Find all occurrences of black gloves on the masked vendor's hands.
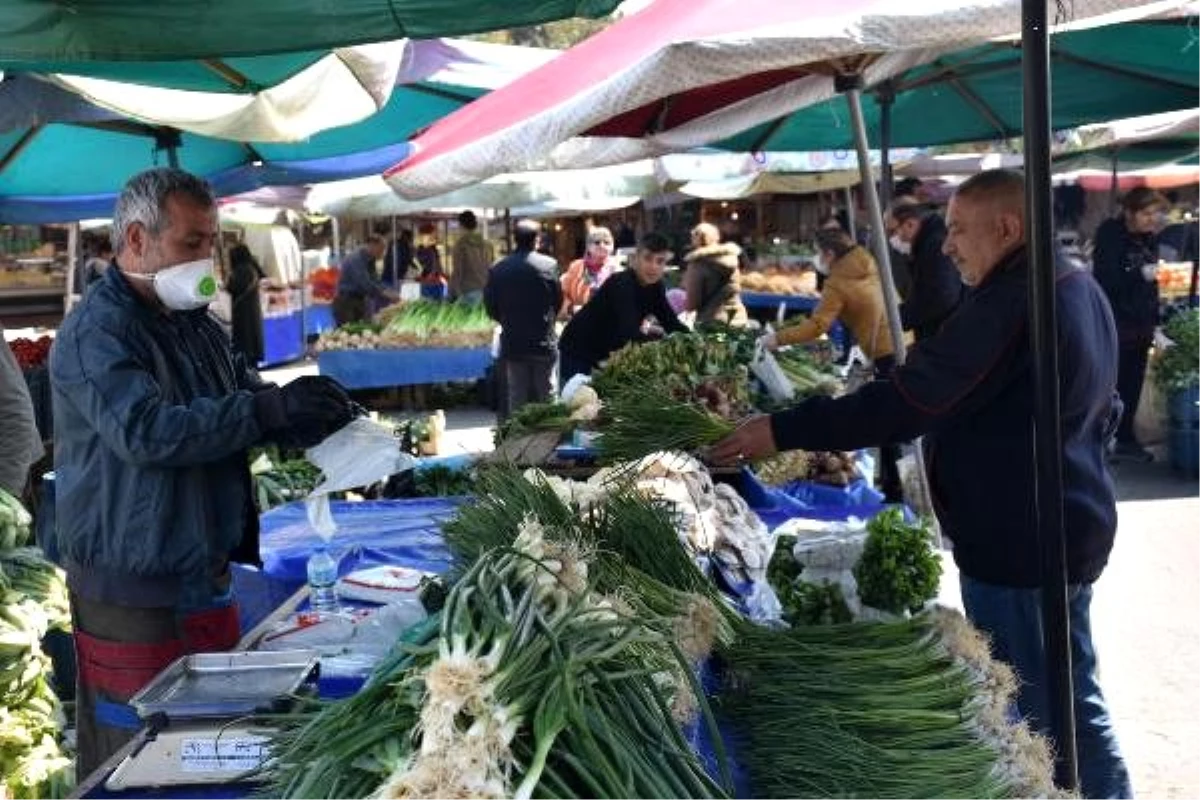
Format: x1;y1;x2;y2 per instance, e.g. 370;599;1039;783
254;375;359;447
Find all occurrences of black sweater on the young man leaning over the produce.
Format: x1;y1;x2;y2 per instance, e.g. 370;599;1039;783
558;270;688;369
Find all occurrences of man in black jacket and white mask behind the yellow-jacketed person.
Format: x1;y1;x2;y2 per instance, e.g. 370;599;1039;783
887;197;962;341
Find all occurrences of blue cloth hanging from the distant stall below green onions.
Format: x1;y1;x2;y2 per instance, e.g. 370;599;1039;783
317;348;492;389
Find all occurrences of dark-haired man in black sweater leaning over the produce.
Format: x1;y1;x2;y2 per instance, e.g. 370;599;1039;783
558;233;688;383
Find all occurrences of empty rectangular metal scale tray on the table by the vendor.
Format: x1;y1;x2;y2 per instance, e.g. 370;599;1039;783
130;650;318;720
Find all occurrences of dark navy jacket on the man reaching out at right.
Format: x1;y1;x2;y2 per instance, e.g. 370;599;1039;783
772;249;1121;588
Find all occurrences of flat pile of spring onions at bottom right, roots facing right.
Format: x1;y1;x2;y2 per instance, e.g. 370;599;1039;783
721;610;1055;800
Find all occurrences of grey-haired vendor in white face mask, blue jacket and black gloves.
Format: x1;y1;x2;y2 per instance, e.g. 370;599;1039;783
50;169;354;776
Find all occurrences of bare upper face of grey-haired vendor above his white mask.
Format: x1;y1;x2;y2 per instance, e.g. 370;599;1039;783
121;194;220;275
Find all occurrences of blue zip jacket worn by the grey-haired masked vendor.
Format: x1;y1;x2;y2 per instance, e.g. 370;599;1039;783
50;269;268;608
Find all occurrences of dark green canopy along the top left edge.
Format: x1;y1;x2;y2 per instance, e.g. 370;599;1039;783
0;0;618;62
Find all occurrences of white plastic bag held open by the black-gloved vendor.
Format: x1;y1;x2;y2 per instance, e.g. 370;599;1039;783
305;416;416;541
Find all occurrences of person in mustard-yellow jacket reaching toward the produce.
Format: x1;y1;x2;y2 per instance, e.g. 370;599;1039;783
766;228;895;374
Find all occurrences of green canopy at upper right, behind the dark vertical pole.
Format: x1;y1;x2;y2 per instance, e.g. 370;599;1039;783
715;19;1200;151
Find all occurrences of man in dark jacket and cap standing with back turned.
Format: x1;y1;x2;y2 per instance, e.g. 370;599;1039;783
484;219;563;422
